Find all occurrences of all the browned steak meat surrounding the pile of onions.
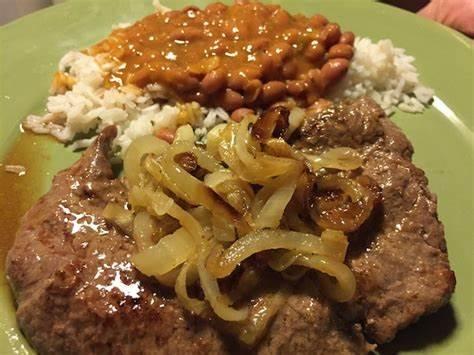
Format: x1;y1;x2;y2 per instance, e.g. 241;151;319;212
7;99;454;354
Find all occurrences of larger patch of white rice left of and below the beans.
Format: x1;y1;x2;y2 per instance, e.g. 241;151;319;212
24;52;229;152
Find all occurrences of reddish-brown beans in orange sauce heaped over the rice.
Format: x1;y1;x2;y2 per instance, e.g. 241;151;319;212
89;1;354;111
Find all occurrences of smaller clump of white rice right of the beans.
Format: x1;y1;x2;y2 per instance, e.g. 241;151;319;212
331;38;434;114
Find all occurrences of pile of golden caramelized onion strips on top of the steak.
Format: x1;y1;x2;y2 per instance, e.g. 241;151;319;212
121;105;362;326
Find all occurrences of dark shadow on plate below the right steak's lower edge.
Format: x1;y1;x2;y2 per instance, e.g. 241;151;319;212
378;303;457;355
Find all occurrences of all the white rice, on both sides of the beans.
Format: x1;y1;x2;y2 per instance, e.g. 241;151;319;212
24;34;433;153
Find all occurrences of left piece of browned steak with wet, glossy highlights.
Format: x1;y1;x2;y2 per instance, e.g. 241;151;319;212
7;127;368;354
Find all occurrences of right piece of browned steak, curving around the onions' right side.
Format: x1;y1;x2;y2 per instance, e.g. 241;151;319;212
297;98;456;344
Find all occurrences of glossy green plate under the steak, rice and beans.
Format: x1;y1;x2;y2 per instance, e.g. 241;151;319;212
0;0;474;354
